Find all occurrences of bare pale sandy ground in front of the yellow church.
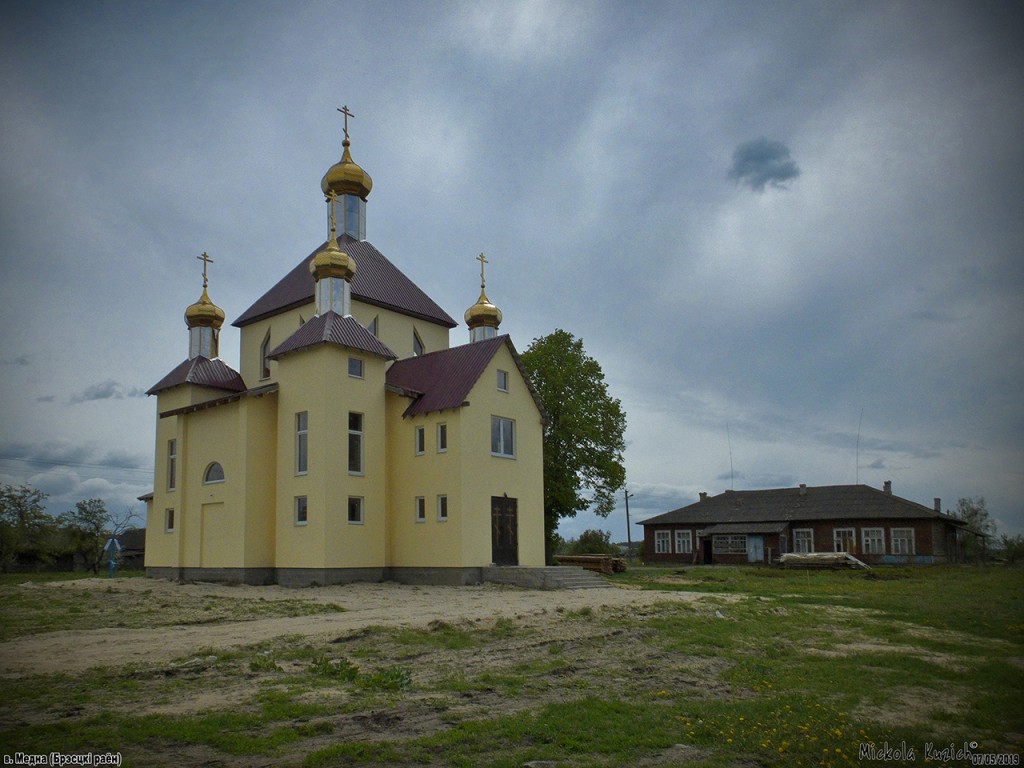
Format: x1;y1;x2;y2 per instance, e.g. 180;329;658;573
0;579;720;677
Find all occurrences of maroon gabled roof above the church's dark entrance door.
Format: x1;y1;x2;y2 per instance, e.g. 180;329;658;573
387;336;544;417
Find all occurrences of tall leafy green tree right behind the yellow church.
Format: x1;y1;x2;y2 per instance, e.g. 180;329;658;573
522;330;626;560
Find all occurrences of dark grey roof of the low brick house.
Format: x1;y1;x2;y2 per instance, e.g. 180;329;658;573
640;485;963;525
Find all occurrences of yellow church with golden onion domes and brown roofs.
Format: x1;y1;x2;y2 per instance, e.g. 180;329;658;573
144;110;544;586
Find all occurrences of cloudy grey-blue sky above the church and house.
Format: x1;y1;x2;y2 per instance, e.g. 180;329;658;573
0;0;1024;540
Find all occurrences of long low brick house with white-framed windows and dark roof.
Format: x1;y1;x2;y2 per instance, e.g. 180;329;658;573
640;480;970;564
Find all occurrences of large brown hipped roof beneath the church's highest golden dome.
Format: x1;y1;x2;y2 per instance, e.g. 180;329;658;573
231;234;458;328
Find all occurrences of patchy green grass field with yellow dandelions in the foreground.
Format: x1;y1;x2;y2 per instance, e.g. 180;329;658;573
0;566;1024;767
